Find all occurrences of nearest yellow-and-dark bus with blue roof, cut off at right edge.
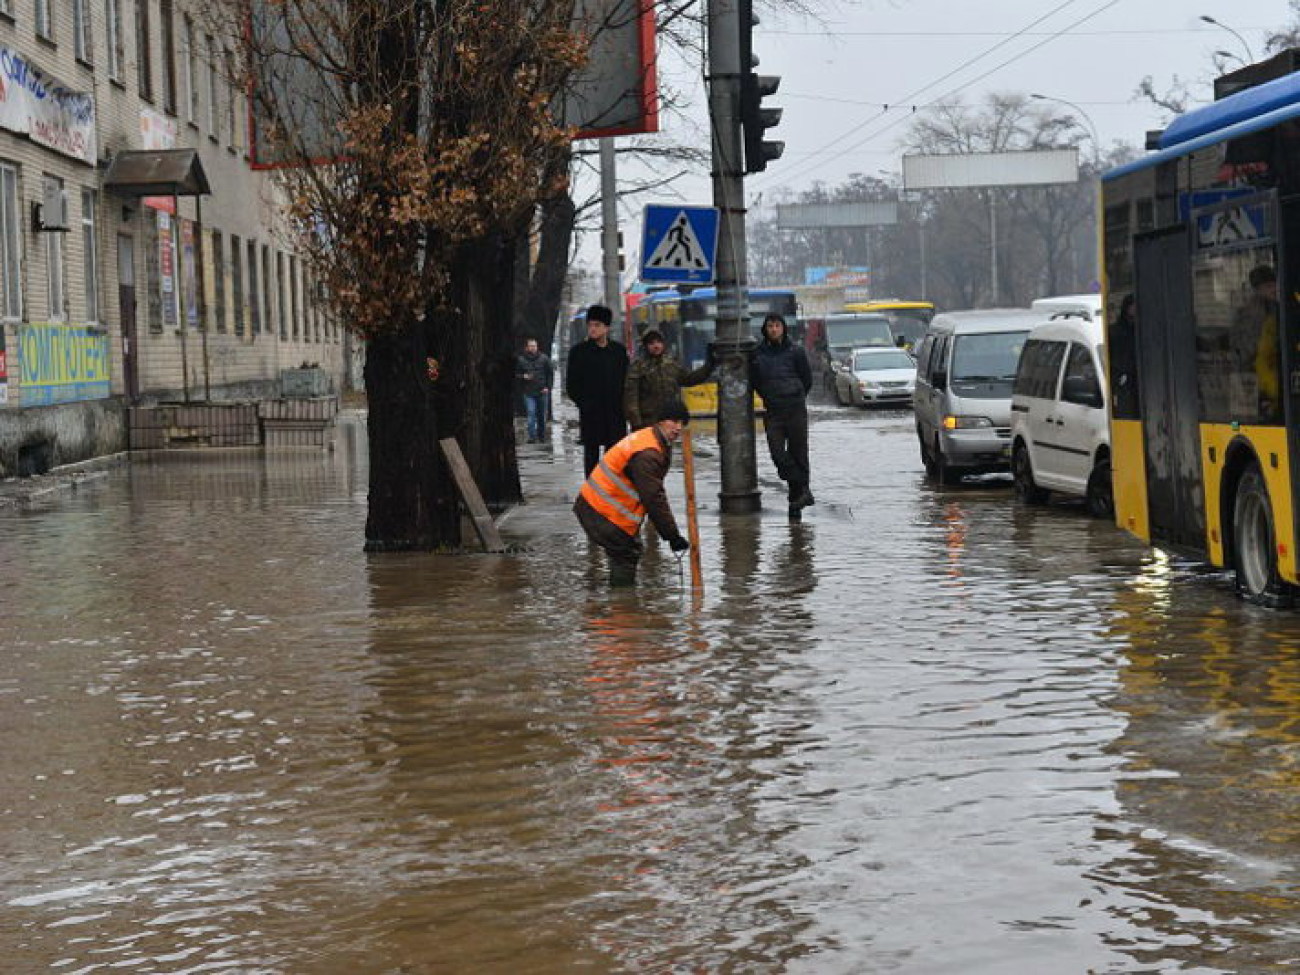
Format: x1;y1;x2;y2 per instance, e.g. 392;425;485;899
1101;62;1300;606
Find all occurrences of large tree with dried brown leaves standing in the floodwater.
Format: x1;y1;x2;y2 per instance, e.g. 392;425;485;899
212;0;588;550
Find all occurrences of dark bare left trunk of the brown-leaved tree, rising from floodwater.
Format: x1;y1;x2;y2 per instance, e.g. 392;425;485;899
365;325;462;551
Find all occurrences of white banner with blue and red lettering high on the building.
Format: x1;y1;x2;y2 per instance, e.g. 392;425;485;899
0;46;99;165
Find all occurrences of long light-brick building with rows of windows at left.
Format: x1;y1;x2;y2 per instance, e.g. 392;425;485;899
0;0;350;476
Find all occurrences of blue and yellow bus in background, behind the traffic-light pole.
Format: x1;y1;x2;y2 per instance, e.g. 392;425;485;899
628;287;803;416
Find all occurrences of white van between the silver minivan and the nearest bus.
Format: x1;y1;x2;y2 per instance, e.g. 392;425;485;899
1011;315;1114;517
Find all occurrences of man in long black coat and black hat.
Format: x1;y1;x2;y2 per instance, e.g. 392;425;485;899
564;304;628;475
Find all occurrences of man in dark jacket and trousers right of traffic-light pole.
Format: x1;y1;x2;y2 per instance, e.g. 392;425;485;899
749;313;813;519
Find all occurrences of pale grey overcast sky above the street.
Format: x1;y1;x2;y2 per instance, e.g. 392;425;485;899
584;0;1290;282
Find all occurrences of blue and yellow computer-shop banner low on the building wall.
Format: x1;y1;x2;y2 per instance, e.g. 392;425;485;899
18;321;109;407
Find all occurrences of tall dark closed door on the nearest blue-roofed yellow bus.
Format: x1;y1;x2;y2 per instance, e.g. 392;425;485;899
1134;225;1205;553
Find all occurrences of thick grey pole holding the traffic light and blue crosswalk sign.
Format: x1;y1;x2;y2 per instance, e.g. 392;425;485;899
709;0;762;514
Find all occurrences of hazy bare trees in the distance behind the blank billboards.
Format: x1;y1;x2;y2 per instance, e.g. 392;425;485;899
748;94;1136;308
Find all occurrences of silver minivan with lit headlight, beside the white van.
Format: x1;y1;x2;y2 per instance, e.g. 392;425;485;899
913;308;1043;484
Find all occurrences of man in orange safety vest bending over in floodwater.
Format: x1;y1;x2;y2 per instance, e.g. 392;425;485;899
573;402;690;586
